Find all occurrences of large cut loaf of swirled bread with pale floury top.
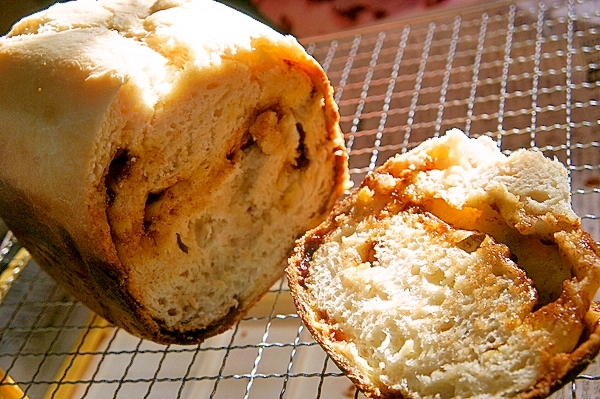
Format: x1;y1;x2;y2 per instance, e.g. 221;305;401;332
0;0;348;344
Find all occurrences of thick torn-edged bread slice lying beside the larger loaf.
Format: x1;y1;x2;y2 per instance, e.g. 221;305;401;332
287;130;600;399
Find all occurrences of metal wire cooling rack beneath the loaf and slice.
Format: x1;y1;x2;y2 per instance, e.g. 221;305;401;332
0;0;600;399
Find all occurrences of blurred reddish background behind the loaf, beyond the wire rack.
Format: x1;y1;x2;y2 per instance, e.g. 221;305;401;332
0;0;473;37
